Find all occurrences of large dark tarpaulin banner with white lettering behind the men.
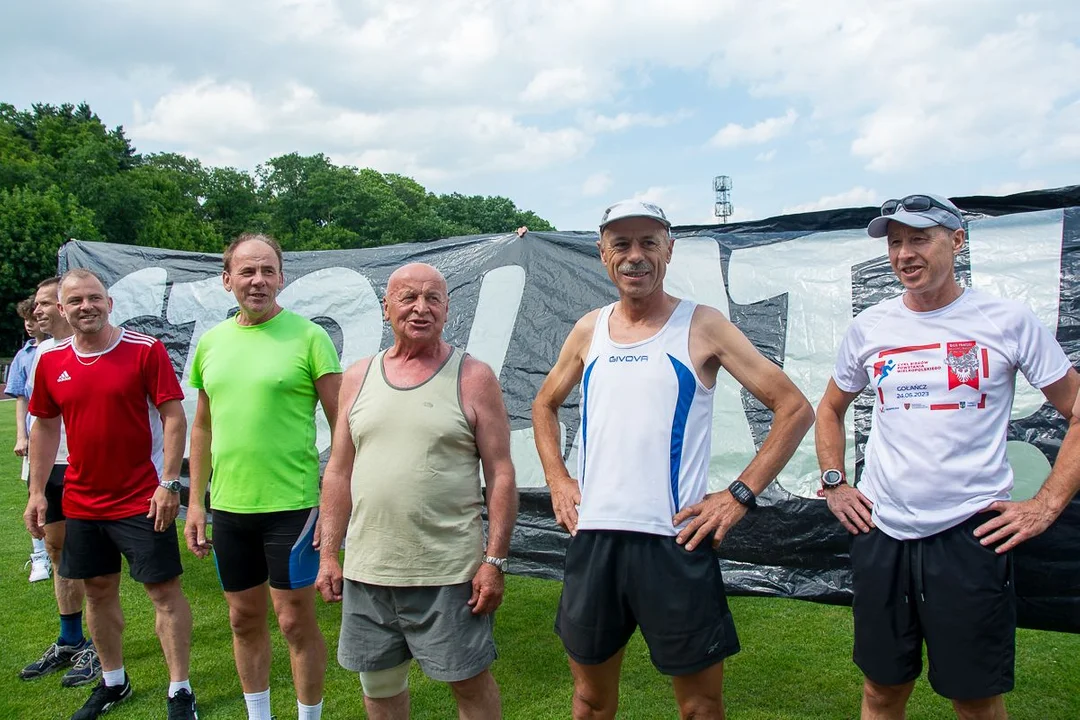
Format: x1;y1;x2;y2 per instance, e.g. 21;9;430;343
59;187;1080;633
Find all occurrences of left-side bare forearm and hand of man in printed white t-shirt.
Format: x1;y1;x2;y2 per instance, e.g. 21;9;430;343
814;378;874;534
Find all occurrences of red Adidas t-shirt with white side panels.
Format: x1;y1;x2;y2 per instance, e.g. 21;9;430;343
29;330;184;520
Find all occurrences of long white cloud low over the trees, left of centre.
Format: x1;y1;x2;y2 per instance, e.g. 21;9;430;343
131;79;592;181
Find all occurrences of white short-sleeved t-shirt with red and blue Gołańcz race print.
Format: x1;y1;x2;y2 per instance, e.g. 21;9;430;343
833;289;1070;540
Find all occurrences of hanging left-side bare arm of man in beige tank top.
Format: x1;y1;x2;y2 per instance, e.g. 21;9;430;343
315;357;372;602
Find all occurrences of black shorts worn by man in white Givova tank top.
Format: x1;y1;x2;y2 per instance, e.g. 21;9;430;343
555;530;739;675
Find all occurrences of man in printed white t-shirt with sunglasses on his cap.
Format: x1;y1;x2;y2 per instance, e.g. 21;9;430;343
815;194;1080;720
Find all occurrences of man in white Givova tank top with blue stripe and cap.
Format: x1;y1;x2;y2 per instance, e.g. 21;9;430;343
532;201;813;718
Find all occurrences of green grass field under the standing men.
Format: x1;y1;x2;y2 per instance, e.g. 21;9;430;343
0;402;1080;720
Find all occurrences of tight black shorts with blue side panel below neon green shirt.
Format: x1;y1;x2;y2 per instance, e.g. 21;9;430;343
212;507;319;593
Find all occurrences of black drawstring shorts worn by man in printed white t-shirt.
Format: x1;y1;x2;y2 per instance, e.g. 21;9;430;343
851;513;1016;699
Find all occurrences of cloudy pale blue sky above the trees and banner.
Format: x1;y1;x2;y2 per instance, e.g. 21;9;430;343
0;0;1080;230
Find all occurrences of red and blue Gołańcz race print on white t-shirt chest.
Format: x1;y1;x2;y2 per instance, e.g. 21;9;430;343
873;340;989;412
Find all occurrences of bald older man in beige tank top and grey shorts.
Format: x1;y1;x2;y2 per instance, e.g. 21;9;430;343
315;263;517;720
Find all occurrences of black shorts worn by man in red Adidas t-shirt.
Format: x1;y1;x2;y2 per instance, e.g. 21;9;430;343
60;514;184;583
